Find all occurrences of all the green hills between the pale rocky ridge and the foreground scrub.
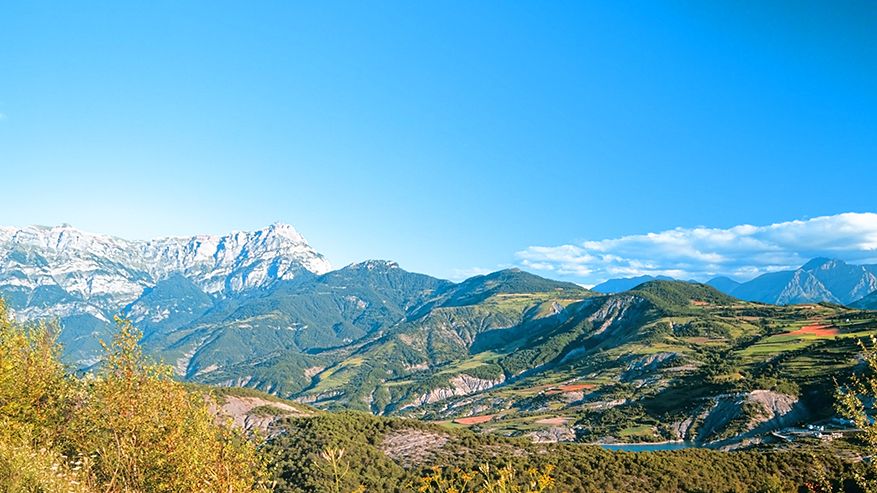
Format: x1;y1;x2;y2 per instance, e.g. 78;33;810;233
114;270;877;447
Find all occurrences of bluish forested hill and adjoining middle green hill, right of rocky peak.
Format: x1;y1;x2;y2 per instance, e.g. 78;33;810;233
164;262;594;413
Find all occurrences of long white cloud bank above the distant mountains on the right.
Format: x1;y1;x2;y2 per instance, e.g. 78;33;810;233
515;213;877;283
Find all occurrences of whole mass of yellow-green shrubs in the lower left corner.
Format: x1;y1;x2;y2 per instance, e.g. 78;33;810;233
0;300;266;493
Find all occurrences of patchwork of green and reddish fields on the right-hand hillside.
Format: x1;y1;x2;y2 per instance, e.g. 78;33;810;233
414;296;877;442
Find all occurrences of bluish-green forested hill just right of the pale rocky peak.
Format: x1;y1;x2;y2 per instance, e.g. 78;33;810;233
146;261;453;380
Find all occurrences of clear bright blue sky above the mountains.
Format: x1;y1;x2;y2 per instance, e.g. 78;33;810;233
0;1;877;284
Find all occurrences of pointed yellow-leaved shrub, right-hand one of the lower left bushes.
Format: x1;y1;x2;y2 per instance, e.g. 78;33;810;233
71;319;264;492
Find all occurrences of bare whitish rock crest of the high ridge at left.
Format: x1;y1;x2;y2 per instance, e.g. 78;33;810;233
0;223;331;318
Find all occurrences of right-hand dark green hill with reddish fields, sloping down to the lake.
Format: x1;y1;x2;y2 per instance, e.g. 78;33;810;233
407;281;877;442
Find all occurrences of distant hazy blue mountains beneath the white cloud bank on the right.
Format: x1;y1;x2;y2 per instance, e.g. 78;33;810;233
593;258;877;305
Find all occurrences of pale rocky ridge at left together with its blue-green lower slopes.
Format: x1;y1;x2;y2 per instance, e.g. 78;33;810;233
0;223;331;365
